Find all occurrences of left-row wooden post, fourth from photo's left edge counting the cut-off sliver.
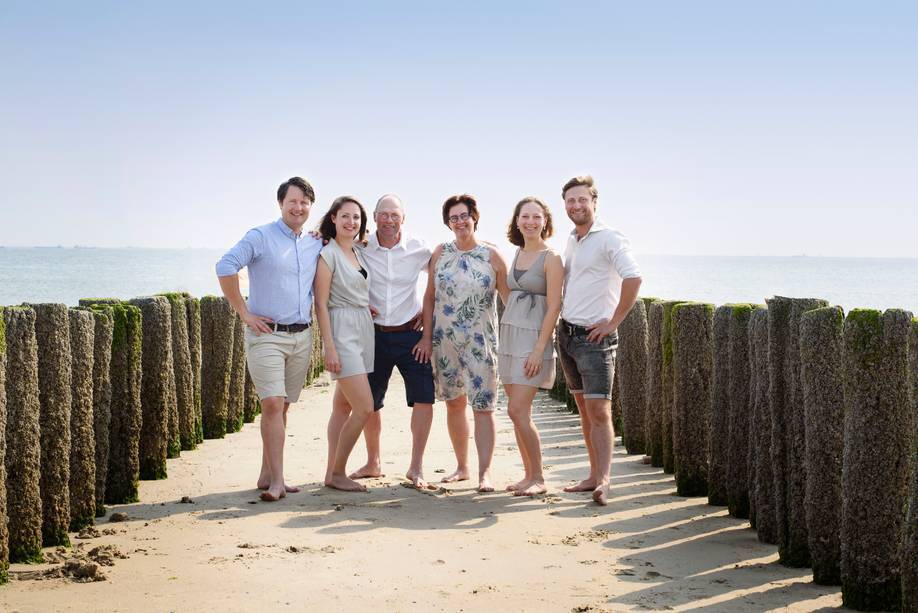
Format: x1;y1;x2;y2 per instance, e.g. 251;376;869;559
68;309;96;532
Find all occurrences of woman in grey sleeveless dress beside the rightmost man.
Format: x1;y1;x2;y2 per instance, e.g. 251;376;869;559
498;196;564;496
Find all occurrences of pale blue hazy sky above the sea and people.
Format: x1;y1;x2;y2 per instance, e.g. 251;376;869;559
0;0;918;257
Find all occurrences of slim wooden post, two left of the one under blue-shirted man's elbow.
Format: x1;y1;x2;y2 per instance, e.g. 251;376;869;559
163;293;198;451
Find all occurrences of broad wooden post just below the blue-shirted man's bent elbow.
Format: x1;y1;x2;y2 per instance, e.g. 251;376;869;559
201;296;236;439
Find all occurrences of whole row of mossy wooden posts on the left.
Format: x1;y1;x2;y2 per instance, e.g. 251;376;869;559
0;293;322;583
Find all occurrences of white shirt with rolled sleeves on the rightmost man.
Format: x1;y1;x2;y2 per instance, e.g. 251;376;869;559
561;219;641;326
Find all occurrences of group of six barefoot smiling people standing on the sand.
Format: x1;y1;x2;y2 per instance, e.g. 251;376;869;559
216;175;641;505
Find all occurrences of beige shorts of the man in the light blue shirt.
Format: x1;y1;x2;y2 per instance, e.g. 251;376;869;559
245;328;312;403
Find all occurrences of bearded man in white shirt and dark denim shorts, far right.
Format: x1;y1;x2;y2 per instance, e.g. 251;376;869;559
558;175;641;505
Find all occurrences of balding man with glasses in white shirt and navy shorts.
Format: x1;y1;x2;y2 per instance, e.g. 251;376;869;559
351;194;434;488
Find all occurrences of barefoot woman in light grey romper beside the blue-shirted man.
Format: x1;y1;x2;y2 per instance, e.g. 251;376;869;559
314;196;374;491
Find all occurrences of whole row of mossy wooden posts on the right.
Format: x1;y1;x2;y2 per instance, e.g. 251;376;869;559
552;297;918;611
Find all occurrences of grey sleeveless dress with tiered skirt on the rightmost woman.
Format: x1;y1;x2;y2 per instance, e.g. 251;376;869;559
497;249;555;389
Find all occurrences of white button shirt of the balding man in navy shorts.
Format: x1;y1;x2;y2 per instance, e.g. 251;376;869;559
363;230;431;326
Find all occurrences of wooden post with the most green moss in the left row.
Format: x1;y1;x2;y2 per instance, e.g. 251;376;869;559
105;304;143;504
